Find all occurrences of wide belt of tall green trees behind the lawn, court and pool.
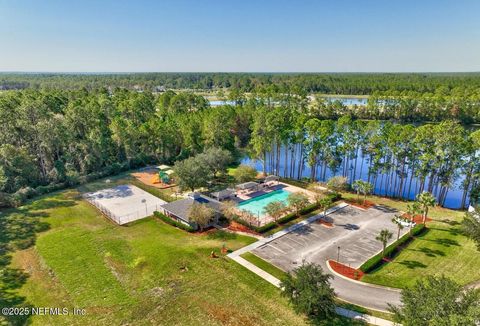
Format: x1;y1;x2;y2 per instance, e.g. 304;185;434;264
0;87;480;206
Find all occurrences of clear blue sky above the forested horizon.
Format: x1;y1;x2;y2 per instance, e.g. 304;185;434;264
0;0;480;72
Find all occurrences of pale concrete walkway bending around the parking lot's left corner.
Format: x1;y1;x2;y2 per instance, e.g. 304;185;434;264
228;203;397;326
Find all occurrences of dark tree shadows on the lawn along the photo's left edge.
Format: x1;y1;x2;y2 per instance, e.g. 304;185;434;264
0;198;56;325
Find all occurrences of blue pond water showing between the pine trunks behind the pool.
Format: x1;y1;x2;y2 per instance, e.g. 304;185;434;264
241;145;468;208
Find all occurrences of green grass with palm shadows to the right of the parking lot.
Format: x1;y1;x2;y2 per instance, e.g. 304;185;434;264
344;194;480;288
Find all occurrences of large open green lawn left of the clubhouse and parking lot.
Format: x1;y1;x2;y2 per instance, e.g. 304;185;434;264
0;186;312;325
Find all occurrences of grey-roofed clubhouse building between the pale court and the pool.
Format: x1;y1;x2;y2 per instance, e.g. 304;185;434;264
162;192;221;228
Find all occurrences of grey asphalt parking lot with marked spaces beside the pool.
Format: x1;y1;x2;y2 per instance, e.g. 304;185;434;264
252;206;408;271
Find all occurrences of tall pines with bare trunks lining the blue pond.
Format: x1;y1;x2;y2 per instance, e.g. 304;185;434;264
250;98;480;207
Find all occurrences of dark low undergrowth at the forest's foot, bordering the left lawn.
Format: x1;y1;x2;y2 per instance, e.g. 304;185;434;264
0;162;144;207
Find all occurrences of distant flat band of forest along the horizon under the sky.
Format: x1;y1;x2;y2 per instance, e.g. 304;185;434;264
0;73;480;95
